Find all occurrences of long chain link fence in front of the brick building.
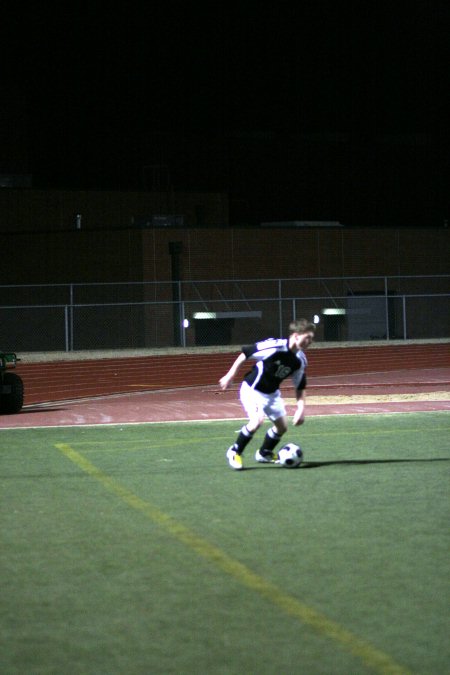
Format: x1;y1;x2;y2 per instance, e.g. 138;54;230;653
0;275;450;352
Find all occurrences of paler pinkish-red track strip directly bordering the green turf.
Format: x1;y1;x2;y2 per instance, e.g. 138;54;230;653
0;368;450;428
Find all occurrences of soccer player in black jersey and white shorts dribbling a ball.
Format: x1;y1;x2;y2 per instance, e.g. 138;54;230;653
219;319;316;470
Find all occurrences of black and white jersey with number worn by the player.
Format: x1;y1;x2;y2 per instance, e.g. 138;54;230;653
242;338;308;394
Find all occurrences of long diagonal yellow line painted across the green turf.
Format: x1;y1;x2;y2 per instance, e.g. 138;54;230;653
55;443;411;675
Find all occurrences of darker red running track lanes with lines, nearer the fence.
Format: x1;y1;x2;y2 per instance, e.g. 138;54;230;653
12;342;450;405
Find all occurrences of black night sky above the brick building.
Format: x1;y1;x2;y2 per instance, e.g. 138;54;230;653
0;0;449;225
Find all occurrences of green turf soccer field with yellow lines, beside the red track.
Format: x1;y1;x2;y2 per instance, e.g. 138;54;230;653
0;412;450;675
